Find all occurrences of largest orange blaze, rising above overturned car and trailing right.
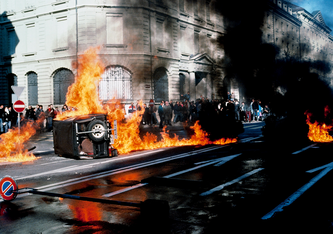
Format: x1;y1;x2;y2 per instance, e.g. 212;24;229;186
56;47;237;154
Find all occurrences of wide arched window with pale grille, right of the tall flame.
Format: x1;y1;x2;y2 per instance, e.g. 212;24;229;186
99;66;132;101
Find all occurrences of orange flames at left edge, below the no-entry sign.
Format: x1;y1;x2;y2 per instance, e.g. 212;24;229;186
0;118;44;162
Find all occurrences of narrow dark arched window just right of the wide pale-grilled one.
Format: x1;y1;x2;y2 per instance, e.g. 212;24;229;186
154;67;169;102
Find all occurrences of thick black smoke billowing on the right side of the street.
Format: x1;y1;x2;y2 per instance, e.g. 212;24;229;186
216;0;333;141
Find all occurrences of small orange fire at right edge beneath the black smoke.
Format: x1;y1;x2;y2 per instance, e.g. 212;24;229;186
305;107;333;142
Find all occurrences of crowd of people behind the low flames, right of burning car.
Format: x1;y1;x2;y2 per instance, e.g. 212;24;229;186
128;94;271;128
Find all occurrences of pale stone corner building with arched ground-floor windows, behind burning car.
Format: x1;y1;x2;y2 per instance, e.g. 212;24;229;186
0;0;223;105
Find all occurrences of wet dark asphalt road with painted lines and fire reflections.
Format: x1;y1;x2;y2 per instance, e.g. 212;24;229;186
0;122;333;233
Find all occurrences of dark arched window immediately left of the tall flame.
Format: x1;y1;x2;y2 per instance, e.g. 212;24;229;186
53;68;74;105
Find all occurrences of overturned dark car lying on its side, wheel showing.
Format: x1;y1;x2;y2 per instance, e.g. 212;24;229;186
53;114;118;158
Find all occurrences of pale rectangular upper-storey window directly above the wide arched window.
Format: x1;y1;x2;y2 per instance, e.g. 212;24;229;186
106;13;124;45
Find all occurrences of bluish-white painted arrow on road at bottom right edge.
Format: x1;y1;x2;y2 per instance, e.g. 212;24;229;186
261;162;333;219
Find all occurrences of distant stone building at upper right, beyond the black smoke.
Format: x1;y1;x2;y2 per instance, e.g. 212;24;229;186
262;0;333;77
